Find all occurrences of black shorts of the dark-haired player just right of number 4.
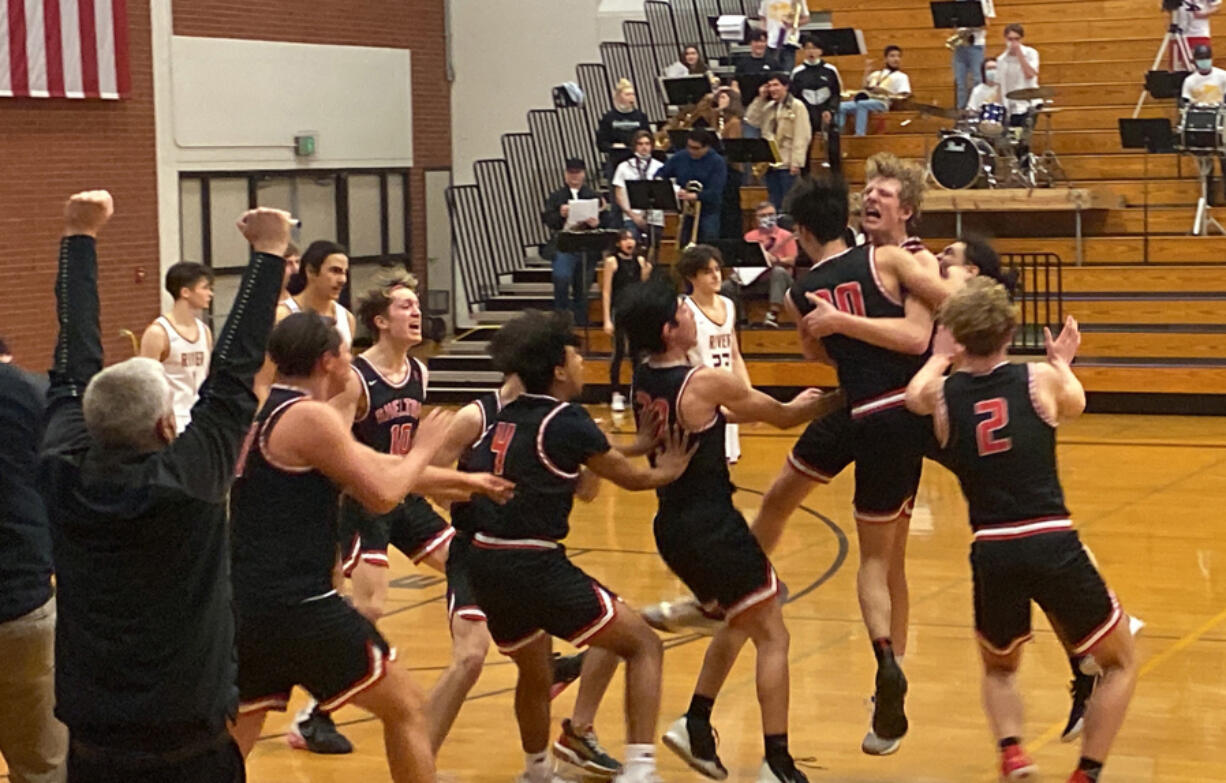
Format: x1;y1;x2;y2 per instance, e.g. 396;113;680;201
652;500;779;620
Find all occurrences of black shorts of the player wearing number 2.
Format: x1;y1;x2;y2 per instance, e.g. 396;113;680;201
971;520;1123;656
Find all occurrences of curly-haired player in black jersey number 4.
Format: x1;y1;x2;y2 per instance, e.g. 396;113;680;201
452;311;689;783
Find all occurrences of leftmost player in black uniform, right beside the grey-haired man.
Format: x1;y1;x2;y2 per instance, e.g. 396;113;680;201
230;312;450;783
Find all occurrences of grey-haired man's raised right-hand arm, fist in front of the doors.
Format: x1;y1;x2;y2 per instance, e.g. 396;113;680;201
162;208;291;502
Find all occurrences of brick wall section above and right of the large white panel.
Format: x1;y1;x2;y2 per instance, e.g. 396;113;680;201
174;0;451;289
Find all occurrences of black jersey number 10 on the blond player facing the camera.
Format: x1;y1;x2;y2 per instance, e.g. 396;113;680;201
353;357;425;456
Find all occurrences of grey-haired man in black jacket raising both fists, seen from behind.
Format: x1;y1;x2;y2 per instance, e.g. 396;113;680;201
40;191;289;783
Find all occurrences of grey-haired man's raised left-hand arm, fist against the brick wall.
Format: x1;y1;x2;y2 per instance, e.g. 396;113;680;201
43;190;115;460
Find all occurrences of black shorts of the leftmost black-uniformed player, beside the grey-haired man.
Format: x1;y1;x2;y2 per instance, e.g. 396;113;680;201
237;593;396;714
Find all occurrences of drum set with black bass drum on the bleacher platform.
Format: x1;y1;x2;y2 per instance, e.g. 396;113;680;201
907;87;1068;190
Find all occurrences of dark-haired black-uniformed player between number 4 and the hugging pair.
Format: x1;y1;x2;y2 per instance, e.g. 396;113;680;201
618;283;829;783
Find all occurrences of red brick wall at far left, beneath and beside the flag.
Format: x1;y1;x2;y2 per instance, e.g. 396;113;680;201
0;0;159;370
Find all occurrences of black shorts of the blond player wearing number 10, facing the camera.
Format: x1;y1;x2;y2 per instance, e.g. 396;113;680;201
340;495;455;576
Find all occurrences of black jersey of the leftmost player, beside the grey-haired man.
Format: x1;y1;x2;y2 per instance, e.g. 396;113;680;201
230;386;340;610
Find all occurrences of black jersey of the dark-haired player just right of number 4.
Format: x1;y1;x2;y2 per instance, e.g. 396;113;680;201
633;363;733;510
